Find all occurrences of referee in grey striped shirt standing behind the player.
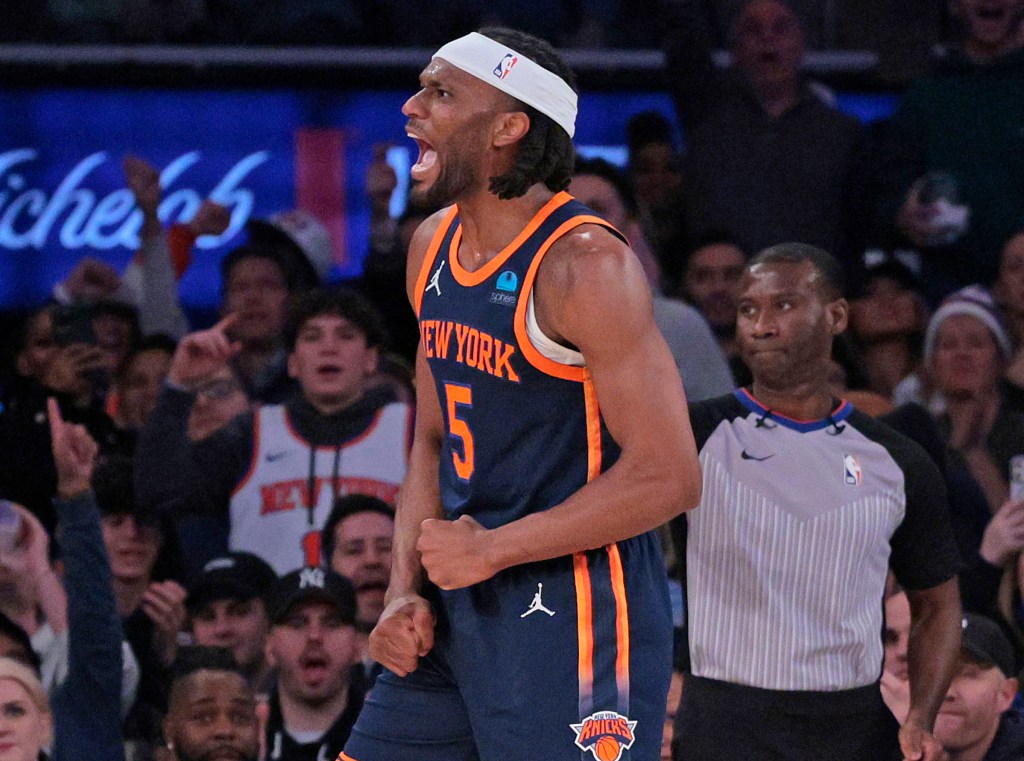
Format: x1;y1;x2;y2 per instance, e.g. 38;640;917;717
673;244;961;761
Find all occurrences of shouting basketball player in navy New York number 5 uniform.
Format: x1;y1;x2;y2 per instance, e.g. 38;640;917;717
341;30;700;761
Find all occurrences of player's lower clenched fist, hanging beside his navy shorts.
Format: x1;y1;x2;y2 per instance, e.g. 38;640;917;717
370;594;434;676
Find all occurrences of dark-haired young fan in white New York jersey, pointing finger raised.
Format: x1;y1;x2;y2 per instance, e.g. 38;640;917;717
137;289;411;573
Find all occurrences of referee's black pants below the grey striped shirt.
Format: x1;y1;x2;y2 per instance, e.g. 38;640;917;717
672;674;903;761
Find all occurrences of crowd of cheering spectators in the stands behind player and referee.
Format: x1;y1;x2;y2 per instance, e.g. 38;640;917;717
0;0;1024;761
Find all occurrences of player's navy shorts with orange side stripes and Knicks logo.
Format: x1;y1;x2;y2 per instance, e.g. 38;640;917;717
341;534;672;761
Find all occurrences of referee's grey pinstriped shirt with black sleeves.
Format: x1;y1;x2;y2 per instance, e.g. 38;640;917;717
674;389;959;691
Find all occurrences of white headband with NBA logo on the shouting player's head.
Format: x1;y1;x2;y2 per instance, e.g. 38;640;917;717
434;32;577;137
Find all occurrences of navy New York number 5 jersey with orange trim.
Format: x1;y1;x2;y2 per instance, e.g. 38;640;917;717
415;193;620;529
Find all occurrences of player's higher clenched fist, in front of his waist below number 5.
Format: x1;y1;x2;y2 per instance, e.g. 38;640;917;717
416;515;498;589
